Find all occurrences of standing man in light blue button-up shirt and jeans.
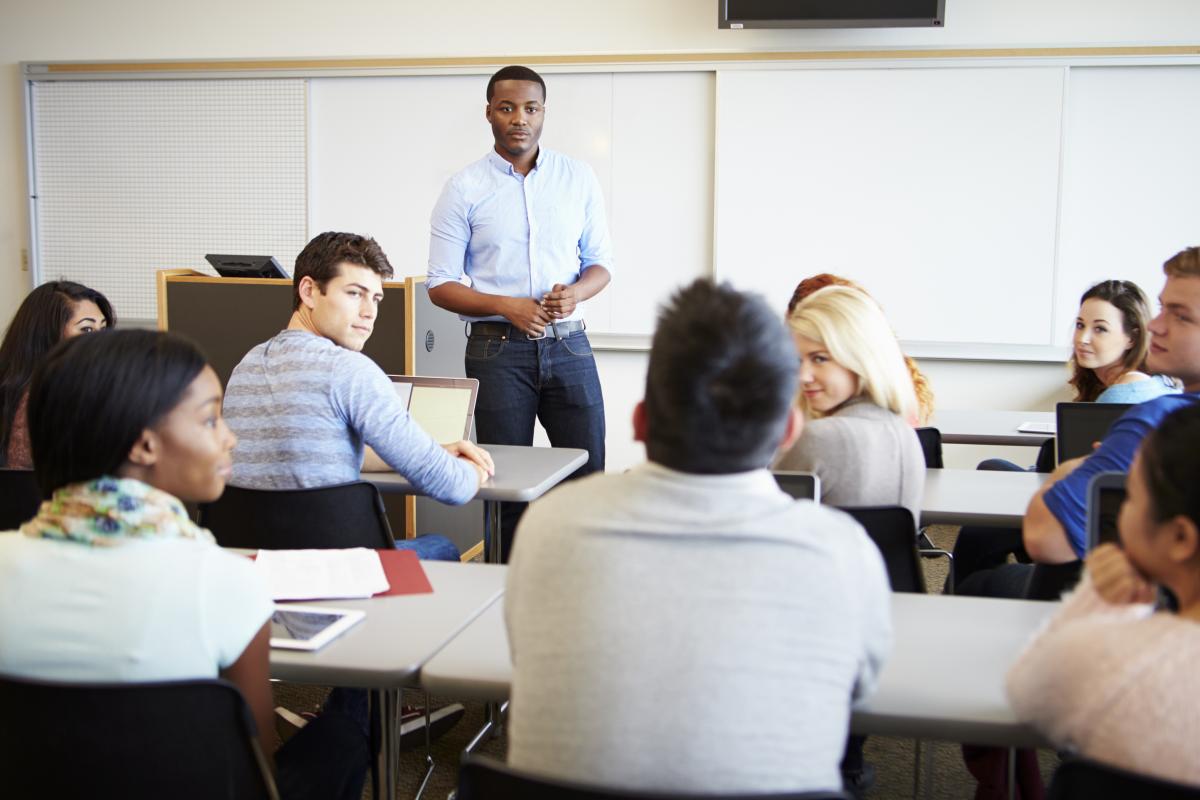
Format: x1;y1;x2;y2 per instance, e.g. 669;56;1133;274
426;66;612;561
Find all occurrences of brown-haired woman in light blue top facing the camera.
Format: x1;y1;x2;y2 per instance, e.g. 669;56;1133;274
1068;281;1180;403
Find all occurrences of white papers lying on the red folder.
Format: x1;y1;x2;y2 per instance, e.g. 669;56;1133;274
254;547;390;600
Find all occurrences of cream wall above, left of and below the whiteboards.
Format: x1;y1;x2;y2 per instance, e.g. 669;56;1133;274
0;0;1200;469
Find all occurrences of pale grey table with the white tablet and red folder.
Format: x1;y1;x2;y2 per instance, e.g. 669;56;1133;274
271;561;508;799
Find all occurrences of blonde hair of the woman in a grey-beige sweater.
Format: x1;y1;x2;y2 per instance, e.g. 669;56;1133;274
787;285;917;420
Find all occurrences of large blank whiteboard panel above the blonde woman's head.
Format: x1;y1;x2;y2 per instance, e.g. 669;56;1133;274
716;67;1064;347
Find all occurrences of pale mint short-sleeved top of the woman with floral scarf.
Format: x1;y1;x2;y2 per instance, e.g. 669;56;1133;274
0;533;272;682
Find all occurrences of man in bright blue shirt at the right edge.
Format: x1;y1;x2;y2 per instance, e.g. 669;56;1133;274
956;247;1200;597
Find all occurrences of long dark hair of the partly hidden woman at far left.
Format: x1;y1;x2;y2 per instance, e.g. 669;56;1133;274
0;281;116;463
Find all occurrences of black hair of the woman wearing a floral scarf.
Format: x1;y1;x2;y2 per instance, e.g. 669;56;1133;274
29;330;206;498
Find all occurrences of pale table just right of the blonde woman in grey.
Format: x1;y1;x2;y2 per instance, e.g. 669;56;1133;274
920;469;1050;528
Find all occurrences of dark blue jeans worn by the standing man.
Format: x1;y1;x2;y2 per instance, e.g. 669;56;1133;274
466;331;605;560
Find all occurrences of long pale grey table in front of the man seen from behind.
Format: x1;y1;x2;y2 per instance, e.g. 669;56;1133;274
420;594;1058;747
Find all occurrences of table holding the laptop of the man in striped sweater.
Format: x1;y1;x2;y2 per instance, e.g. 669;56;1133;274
359;445;588;564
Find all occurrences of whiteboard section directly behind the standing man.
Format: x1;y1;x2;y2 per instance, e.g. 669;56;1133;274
308;72;713;335
